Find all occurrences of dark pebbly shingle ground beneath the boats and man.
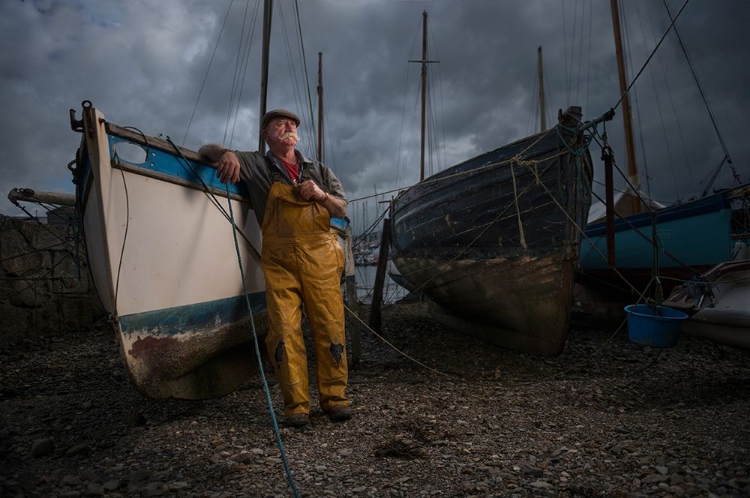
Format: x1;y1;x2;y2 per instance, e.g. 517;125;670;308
0;303;750;497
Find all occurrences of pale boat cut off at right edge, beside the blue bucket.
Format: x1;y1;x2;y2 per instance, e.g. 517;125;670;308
664;259;750;350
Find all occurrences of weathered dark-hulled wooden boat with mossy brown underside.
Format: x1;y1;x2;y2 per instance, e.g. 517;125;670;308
391;110;592;356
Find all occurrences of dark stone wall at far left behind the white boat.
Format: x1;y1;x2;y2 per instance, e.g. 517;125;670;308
0;215;105;347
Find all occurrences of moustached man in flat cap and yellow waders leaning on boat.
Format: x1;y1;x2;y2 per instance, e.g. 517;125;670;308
199;109;352;427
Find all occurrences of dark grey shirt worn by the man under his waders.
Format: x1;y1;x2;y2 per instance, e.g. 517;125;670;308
235;150;346;226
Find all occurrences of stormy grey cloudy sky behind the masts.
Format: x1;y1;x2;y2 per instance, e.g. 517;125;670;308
0;0;750;229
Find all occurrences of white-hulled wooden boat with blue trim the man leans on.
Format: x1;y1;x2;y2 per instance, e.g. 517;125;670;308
71;102;265;398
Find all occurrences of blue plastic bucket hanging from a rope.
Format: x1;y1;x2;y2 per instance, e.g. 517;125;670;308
625;304;688;348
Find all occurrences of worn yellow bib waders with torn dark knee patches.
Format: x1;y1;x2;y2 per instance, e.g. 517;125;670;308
262;182;349;417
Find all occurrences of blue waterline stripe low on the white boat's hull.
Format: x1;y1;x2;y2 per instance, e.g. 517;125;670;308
119;292;266;336
